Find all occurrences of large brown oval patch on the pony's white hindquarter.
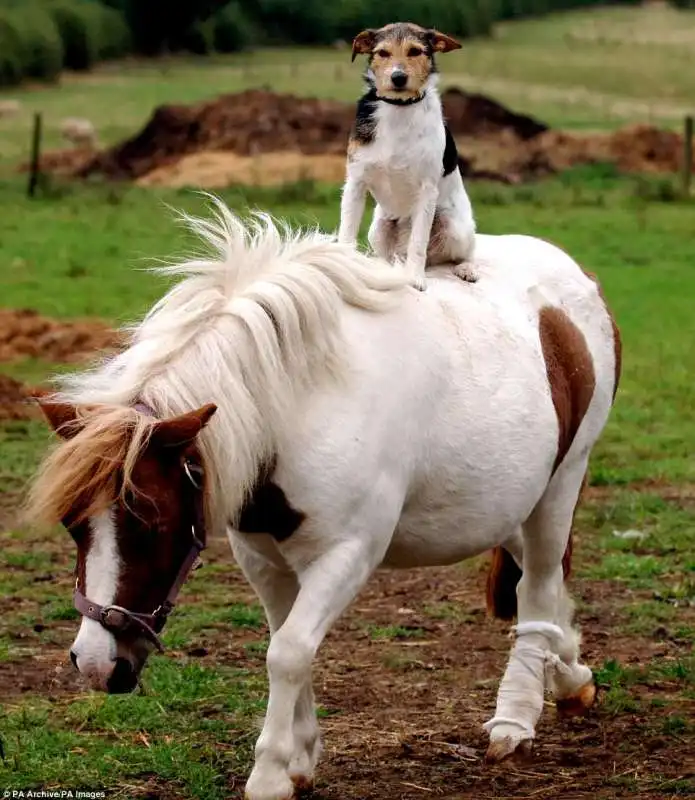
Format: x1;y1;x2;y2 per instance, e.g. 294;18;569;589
538;306;596;472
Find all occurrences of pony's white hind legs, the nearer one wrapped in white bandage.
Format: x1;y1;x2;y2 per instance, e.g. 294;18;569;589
485;461;593;761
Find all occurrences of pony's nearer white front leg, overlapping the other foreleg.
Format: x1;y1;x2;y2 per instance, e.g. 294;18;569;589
246;534;384;800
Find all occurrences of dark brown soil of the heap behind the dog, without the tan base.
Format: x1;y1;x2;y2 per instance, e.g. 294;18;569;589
69;89;547;180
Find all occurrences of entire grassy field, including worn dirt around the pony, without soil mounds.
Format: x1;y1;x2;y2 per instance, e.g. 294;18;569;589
0;9;695;800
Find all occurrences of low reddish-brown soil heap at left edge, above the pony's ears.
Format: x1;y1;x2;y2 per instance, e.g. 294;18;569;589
0;308;120;362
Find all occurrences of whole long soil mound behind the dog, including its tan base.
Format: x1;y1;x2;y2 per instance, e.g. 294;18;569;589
24;88;683;188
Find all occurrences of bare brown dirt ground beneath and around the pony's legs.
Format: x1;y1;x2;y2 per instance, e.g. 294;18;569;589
0;520;695;800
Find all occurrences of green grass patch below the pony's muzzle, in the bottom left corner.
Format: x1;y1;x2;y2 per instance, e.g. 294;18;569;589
0;658;263;800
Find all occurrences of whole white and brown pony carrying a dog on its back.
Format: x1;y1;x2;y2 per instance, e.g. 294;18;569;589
29;205;620;800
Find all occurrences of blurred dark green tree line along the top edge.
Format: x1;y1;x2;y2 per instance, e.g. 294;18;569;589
0;0;676;86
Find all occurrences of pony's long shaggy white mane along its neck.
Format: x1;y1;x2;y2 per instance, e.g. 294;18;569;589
60;199;406;530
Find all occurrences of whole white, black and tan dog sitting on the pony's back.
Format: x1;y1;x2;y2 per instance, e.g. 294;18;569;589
338;22;475;290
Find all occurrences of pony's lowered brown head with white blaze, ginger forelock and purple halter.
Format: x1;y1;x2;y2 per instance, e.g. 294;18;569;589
27;399;216;693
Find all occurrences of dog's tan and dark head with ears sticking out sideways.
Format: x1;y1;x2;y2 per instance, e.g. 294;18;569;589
352;22;461;99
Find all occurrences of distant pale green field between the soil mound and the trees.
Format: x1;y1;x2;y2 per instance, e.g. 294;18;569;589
0;7;695;169
